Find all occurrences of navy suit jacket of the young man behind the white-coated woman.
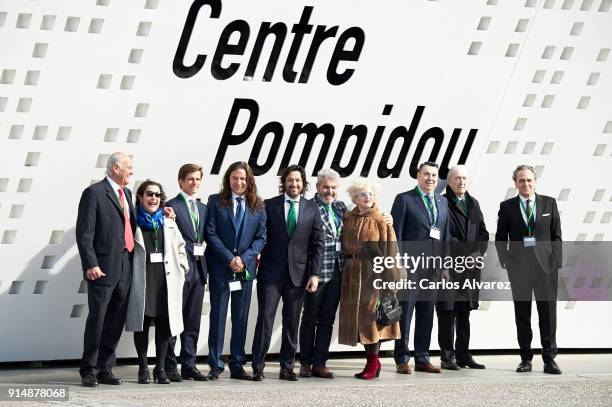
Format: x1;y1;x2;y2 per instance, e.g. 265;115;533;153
166;193;208;285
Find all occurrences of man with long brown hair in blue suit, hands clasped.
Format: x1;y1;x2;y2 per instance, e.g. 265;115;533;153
206;161;266;380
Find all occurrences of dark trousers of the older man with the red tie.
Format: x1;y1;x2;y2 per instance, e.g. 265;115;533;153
79;250;132;377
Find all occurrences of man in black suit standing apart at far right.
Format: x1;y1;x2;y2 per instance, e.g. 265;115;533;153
495;165;562;374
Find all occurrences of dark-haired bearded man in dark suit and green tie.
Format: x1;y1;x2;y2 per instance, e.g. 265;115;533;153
253;165;324;381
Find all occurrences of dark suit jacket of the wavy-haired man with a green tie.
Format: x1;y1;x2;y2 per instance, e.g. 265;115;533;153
257;194;324;287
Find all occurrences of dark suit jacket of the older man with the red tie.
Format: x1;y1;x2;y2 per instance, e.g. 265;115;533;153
75;179;136;286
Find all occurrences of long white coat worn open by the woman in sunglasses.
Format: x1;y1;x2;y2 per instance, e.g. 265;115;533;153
125;218;189;336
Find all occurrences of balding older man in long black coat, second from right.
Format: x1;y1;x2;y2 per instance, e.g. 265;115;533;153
436;165;489;370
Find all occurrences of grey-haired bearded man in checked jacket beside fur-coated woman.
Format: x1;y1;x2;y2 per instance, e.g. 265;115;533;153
299;169;346;379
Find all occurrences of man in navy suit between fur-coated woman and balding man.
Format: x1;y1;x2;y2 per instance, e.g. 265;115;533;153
391;162;450;374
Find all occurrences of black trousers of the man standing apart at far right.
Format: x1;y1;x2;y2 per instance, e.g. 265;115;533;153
508;256;558;363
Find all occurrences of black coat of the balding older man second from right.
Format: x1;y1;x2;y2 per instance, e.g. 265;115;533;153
437;186;489;310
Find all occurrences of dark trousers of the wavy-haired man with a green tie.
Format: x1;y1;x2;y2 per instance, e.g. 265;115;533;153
253;278;305;369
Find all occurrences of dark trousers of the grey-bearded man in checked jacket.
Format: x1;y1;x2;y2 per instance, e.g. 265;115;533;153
300;262;342;367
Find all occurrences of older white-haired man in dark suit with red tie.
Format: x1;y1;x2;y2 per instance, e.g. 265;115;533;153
76;153;136;387
